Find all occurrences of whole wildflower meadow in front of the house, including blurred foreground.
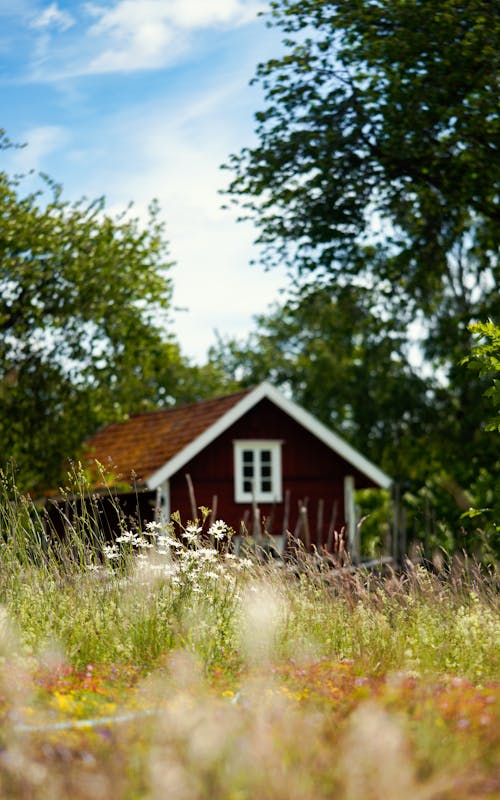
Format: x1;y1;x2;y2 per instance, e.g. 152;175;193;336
0;484;500;800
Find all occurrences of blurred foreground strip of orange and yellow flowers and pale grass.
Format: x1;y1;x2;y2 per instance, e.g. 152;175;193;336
0;654;498;800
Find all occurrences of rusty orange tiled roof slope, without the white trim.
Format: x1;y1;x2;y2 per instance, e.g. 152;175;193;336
84;389;251;483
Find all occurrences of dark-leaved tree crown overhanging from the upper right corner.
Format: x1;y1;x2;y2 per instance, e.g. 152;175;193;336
229;0;500;338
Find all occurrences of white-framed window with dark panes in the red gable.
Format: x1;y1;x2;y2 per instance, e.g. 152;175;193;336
234;439;283;503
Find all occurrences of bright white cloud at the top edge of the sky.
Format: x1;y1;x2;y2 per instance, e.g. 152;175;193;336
86;0;262;73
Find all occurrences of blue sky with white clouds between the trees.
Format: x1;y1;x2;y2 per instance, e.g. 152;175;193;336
0;0;286;362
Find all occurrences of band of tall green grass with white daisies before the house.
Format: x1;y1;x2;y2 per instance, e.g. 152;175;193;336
0;481;500;681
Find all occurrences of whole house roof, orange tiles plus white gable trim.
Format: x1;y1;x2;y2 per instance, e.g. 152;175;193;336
87;383;392;489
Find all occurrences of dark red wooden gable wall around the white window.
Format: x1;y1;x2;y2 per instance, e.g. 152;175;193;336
170;400;373;545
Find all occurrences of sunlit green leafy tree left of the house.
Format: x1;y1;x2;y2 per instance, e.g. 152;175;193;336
0;135;229;488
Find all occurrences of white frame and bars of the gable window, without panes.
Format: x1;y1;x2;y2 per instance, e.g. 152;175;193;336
233;439;283;503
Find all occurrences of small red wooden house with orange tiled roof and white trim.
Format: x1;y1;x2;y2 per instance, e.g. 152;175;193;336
82;383;391;551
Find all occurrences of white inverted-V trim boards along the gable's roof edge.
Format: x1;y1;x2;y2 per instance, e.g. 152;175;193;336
147;382;392;489
